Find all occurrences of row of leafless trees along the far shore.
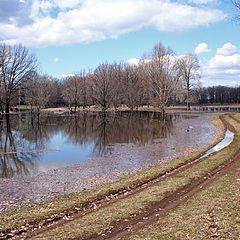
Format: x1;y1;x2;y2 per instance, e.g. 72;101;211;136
0;43;239;115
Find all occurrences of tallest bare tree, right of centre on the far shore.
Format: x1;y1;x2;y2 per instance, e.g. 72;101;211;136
142;43;179;116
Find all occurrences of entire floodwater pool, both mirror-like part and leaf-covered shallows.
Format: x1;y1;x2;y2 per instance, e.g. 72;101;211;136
0;112;216;211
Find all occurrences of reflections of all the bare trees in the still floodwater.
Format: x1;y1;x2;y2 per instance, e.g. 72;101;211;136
0;112;181;178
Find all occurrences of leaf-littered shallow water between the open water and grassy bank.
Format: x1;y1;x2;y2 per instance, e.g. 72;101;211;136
0;114;220;212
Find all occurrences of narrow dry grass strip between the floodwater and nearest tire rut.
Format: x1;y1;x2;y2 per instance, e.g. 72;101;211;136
0;117;223;235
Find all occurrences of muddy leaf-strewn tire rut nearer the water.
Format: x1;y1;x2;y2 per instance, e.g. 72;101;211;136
5;116;233;239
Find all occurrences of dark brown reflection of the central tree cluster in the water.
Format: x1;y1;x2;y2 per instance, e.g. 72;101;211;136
59;112;178;152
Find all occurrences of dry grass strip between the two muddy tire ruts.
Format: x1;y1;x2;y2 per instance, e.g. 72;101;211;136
28;117;240;239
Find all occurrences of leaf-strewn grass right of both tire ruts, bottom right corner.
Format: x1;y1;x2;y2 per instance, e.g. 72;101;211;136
130;114;240;240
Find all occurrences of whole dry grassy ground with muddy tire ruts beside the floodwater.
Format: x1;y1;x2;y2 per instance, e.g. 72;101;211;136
0;114;240;240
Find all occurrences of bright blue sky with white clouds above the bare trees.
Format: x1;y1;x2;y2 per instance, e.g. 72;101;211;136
0;0;240;86
